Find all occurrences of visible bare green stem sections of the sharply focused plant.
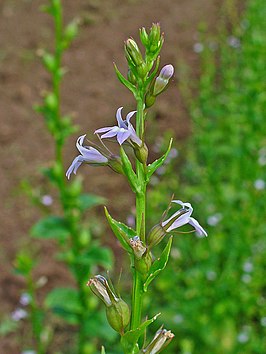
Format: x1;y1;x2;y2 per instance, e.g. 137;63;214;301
130;95;146;330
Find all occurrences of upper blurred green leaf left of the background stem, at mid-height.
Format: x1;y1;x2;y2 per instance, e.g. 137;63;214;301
31;215;69;240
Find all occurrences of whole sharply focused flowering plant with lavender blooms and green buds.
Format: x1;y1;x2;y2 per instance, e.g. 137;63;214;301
66;24;207;354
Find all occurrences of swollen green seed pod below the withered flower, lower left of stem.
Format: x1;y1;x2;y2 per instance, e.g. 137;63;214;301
106;299;130;335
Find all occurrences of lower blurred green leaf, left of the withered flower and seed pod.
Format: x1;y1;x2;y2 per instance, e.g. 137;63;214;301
44;288;83;324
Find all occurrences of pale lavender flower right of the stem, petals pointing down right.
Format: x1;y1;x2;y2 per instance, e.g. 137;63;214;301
162;200;208;236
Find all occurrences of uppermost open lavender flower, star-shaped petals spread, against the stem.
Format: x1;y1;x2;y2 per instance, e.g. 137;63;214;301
94;107;142;146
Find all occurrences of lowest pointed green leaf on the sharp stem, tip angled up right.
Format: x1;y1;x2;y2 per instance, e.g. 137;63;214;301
121;313;160;354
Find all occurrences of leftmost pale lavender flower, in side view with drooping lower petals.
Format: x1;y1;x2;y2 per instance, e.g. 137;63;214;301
66;135;108;179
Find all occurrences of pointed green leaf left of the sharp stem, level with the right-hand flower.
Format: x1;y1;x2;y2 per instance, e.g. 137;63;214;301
104;207;136;254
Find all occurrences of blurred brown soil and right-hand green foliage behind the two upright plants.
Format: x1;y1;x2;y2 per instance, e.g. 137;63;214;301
0;0;266;354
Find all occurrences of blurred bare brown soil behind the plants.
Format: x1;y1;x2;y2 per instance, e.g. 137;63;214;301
0;0;222;354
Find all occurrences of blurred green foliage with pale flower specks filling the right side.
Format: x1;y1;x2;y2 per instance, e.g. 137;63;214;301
147;0;266;354
